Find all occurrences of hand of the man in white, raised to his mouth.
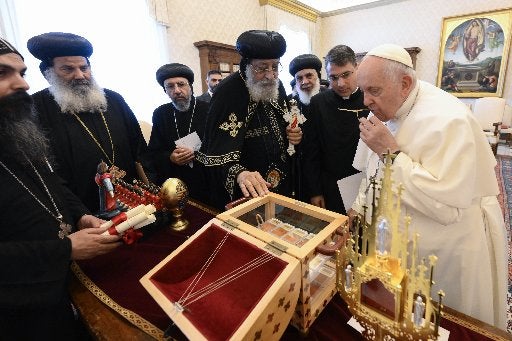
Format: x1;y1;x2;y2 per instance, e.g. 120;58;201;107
359;116;400;158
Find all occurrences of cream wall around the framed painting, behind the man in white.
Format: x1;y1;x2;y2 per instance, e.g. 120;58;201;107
317;0;512;104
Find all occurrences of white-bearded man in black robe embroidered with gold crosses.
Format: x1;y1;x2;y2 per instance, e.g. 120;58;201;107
197;30;302;209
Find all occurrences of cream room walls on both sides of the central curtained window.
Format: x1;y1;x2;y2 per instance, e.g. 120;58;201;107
161;0;512;105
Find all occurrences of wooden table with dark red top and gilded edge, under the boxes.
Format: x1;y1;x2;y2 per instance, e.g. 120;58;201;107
71;202;511;340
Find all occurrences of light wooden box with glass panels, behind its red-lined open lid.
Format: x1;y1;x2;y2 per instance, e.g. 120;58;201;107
217;193;348;332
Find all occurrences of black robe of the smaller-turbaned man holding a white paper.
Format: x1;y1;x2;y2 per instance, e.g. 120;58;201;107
148;98;208;202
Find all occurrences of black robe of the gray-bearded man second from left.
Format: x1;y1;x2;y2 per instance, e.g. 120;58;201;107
32;89;146;212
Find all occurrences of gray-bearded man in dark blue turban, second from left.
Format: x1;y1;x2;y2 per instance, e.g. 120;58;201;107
27;32;147;212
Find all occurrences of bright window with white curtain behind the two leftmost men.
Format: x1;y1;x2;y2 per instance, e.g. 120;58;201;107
0;0;169;122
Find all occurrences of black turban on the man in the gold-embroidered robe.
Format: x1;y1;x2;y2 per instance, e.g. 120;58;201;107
236;30;286;59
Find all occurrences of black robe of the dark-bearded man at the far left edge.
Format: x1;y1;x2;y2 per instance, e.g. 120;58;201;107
0;160;88;340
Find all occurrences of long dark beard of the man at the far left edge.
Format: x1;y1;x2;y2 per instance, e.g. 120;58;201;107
0;91;49;165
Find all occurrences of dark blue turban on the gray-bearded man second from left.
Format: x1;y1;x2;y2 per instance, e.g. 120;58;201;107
27;32;93;73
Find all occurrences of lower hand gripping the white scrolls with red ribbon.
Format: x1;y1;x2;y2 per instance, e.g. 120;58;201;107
68;228;121;260
